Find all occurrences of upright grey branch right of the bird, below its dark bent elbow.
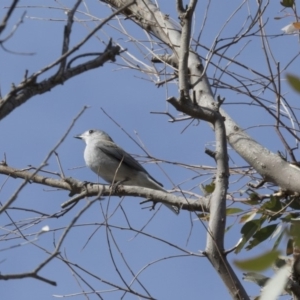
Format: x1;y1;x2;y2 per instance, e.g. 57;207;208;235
168;98;249;299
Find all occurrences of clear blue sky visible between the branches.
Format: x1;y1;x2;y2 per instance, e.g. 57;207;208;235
0;0;298;300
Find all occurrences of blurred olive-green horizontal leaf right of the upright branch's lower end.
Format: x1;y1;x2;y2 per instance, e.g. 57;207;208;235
233;250;280;270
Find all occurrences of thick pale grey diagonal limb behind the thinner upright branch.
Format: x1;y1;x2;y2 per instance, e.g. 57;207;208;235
103;0;300;194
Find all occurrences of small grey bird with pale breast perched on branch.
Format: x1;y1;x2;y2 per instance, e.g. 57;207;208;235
75;129;179;214
